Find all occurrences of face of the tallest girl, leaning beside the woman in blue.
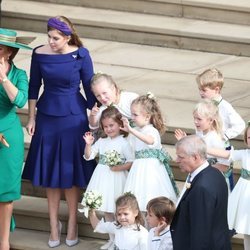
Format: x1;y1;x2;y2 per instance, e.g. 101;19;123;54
92;80;117;106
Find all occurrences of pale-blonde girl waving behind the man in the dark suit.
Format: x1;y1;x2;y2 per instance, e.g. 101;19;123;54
175;99;232;192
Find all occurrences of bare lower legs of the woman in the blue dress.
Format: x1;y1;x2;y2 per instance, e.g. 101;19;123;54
46;187;80;241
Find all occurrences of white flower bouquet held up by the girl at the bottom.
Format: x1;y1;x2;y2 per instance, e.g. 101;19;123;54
78;190;102;218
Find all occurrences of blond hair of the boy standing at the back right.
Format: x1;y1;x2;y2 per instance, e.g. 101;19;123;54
196;68;224;90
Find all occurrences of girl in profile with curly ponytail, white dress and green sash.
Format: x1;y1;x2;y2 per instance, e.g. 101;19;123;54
122;94;178;212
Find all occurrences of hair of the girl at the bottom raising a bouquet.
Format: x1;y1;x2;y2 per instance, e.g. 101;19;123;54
115;192;144;231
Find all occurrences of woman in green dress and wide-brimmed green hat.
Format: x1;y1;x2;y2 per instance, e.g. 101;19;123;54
0;28;33;250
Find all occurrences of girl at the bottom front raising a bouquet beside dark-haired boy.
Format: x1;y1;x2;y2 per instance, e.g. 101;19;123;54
89;193;148;250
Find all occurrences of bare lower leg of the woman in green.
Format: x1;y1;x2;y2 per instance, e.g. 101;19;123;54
0;202;13;250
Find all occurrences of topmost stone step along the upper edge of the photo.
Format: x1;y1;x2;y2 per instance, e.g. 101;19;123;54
21;0;250;25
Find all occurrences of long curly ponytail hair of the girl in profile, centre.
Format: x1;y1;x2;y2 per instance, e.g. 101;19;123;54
131;93;166;134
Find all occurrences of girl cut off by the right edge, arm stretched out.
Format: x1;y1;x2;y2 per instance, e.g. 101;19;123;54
208;121;250;250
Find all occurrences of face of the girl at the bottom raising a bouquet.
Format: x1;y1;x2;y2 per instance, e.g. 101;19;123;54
116;207;138;226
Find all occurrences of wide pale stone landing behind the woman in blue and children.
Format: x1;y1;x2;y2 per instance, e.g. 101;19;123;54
9;31;250;129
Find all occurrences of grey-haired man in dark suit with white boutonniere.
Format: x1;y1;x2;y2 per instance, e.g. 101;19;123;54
171;135;231;250
